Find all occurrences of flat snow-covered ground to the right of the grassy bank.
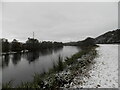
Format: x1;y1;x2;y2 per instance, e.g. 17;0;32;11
73;45;118;88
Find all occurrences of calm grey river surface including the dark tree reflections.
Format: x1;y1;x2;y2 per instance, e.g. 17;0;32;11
2;46;80;85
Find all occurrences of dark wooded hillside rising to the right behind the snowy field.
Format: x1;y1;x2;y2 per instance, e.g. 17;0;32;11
64;29;120;46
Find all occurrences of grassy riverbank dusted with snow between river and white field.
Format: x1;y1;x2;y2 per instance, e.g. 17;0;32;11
3;47;97;89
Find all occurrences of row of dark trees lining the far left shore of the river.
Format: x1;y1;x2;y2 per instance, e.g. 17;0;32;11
1;38;63;52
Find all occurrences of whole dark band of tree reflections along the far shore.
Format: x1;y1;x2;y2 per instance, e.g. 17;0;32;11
2;47;63;68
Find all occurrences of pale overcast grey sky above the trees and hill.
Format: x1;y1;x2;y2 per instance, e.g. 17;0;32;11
2;2;118;42
